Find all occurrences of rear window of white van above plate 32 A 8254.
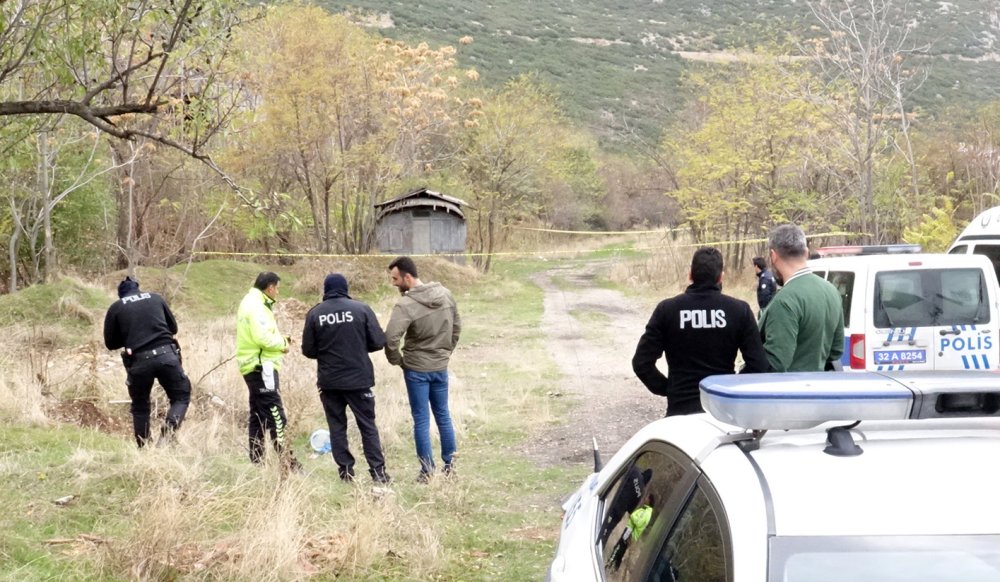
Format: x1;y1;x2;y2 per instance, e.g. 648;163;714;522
873;269;990;328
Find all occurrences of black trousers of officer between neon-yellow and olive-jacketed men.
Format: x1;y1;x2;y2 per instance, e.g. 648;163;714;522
319;389;386;479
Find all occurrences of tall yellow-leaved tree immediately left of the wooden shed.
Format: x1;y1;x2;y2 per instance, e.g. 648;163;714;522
227;5;475;252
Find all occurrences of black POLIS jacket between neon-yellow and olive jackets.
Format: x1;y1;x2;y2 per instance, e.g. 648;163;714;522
302;295;385;390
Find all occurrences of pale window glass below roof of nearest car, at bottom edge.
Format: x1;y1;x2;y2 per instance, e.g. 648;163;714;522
768;535;1000;582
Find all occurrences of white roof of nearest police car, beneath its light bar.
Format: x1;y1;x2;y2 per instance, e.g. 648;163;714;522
748;418;1000;536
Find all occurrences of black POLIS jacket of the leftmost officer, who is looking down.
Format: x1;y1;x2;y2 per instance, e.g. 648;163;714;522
104;291;177;354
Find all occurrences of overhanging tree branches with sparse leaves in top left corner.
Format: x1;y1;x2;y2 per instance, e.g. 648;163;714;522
0;0;255;224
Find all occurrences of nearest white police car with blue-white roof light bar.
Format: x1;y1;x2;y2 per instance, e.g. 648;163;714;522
548;371;1000;582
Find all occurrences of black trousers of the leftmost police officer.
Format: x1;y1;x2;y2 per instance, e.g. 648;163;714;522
126;352;191;447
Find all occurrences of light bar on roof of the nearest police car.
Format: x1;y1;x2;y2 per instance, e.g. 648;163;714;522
701;371;1000;430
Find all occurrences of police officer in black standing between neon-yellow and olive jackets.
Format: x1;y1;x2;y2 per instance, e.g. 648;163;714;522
302;273;389;483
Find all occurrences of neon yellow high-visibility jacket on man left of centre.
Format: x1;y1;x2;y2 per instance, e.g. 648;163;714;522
236;287;287;376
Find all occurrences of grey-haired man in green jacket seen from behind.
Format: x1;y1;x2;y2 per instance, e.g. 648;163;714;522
760;224;844;372
